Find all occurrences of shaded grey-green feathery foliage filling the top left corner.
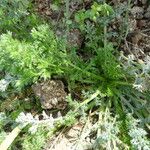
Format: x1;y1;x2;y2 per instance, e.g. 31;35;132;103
0;0;41;39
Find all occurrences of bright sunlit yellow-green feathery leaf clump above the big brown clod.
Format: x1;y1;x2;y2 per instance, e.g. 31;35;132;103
0;25;67;87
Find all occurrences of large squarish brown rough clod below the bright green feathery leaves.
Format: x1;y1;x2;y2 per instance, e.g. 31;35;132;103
32;80;67;109
